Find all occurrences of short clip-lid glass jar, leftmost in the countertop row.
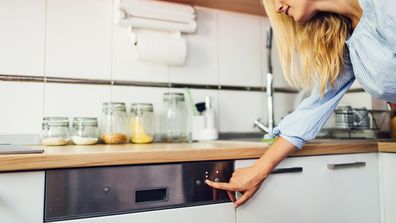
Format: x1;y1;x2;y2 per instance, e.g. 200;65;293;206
41;117;70;146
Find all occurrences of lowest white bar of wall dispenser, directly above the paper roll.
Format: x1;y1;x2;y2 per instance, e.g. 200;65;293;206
122;16;197;33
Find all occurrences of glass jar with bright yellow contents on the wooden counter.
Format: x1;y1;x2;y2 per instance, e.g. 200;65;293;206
129;103;154;143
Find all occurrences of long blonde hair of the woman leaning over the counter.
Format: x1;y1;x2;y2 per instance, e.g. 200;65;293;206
262;0;350;95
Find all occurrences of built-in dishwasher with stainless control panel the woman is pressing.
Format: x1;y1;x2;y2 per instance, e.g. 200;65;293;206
44;161;235;223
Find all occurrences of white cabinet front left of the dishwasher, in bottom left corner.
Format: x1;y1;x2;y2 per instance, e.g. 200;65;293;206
0;172;44;223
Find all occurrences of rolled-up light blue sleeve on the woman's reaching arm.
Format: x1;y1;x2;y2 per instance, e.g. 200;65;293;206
273;66;355;149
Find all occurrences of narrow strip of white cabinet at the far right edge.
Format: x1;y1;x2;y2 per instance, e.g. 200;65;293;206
380;153;396;223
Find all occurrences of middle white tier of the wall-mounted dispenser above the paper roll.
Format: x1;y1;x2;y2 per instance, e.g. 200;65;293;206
120;3;195;23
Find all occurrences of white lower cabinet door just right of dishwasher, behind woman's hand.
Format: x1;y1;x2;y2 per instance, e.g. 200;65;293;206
236;158;313;223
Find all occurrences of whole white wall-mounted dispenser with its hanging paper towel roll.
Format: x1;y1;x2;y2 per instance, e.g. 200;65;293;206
120;0;197;66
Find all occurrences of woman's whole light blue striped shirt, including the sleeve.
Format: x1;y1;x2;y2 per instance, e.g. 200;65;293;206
273;0;396;149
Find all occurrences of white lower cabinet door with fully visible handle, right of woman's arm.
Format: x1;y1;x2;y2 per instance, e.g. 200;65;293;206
307;153;380;223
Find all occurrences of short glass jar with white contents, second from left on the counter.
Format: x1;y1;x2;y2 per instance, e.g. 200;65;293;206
71;117;99;145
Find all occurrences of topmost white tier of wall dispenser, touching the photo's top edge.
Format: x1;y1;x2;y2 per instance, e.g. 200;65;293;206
121;0;195;14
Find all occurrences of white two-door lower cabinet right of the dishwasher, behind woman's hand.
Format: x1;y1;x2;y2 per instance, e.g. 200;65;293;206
236;153;380;223
